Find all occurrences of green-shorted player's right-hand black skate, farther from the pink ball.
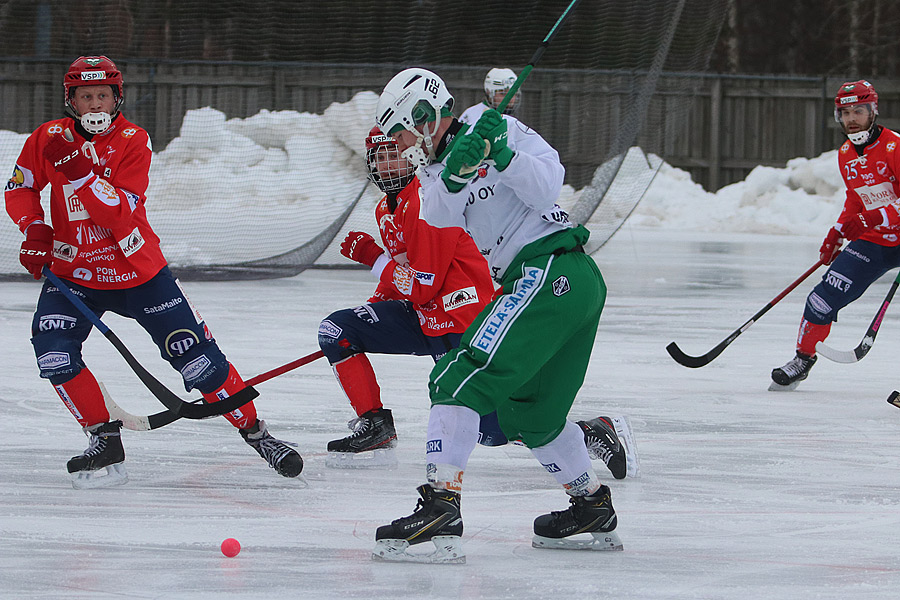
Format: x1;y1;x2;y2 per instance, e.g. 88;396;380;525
531;485;623;550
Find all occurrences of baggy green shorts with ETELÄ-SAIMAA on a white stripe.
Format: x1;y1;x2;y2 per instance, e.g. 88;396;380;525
429;232;606;448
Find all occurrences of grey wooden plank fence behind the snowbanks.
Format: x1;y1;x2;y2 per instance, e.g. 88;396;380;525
0;59;900;190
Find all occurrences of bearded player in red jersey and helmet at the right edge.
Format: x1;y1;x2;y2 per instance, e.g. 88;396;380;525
769;81;900;391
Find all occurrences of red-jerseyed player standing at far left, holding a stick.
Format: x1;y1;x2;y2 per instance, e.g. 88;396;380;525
5;56;303;488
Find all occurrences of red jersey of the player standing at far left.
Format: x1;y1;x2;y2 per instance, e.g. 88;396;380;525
6;114;166;289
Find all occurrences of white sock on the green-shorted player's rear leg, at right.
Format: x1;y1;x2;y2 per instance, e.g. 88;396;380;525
531;420;600;496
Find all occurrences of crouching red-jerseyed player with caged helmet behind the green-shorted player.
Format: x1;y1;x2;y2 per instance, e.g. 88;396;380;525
319;127;637;479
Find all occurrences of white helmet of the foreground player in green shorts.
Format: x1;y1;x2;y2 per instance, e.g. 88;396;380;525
375;68;453;167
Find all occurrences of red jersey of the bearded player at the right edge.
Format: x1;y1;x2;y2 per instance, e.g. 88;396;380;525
838;127;900;246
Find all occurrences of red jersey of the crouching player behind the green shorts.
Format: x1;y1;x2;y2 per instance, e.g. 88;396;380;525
370;178;494;336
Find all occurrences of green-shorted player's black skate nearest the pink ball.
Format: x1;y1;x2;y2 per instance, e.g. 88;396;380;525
372;483;466;563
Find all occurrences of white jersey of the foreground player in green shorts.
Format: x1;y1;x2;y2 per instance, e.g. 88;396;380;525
418;115;571;281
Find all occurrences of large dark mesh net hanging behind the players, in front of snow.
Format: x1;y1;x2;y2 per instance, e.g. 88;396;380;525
0;0;726;278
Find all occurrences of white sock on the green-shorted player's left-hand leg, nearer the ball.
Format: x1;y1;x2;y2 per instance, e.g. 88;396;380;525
425;404;481;492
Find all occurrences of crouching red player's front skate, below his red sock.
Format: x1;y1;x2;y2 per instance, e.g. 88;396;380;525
325;408;397;468
